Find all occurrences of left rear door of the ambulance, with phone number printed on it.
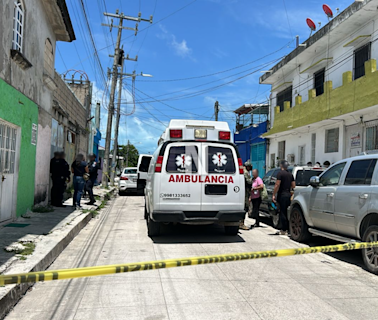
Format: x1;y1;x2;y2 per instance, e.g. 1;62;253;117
159;142;202;211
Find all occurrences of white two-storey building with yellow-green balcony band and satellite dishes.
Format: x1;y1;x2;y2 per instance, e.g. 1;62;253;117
260;0;378;167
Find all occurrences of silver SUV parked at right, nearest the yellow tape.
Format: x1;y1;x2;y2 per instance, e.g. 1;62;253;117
289;154;378;274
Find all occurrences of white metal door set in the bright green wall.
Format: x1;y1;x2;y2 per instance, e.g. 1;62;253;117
0;120;17;222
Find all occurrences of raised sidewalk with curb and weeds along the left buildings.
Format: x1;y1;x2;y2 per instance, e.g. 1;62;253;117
0;187;115;319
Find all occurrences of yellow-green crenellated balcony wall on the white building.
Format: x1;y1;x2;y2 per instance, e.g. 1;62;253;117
264;59;378;136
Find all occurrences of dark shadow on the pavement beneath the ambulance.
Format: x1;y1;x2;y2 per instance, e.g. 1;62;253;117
151;224;245;244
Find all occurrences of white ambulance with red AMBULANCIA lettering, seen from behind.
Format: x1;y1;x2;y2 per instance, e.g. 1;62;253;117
145;120;245;236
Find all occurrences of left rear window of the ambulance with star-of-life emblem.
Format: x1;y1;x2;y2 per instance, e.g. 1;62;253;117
167;146;198;173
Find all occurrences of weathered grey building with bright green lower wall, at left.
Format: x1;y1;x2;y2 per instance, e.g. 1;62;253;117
0;0;75;223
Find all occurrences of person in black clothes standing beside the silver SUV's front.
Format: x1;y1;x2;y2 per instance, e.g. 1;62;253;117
272;160;295;234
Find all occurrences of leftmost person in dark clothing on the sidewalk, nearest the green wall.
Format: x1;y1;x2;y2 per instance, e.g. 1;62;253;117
50;151;66;207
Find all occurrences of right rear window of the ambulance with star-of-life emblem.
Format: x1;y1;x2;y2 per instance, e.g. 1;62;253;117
207;147;236;173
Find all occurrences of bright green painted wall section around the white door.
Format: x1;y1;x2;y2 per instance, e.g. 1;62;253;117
0;79;38;216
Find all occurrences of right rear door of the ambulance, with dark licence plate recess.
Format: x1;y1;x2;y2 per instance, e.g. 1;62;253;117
201;143;244;211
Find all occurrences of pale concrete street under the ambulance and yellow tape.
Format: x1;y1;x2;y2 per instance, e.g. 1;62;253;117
6;196;378;320
